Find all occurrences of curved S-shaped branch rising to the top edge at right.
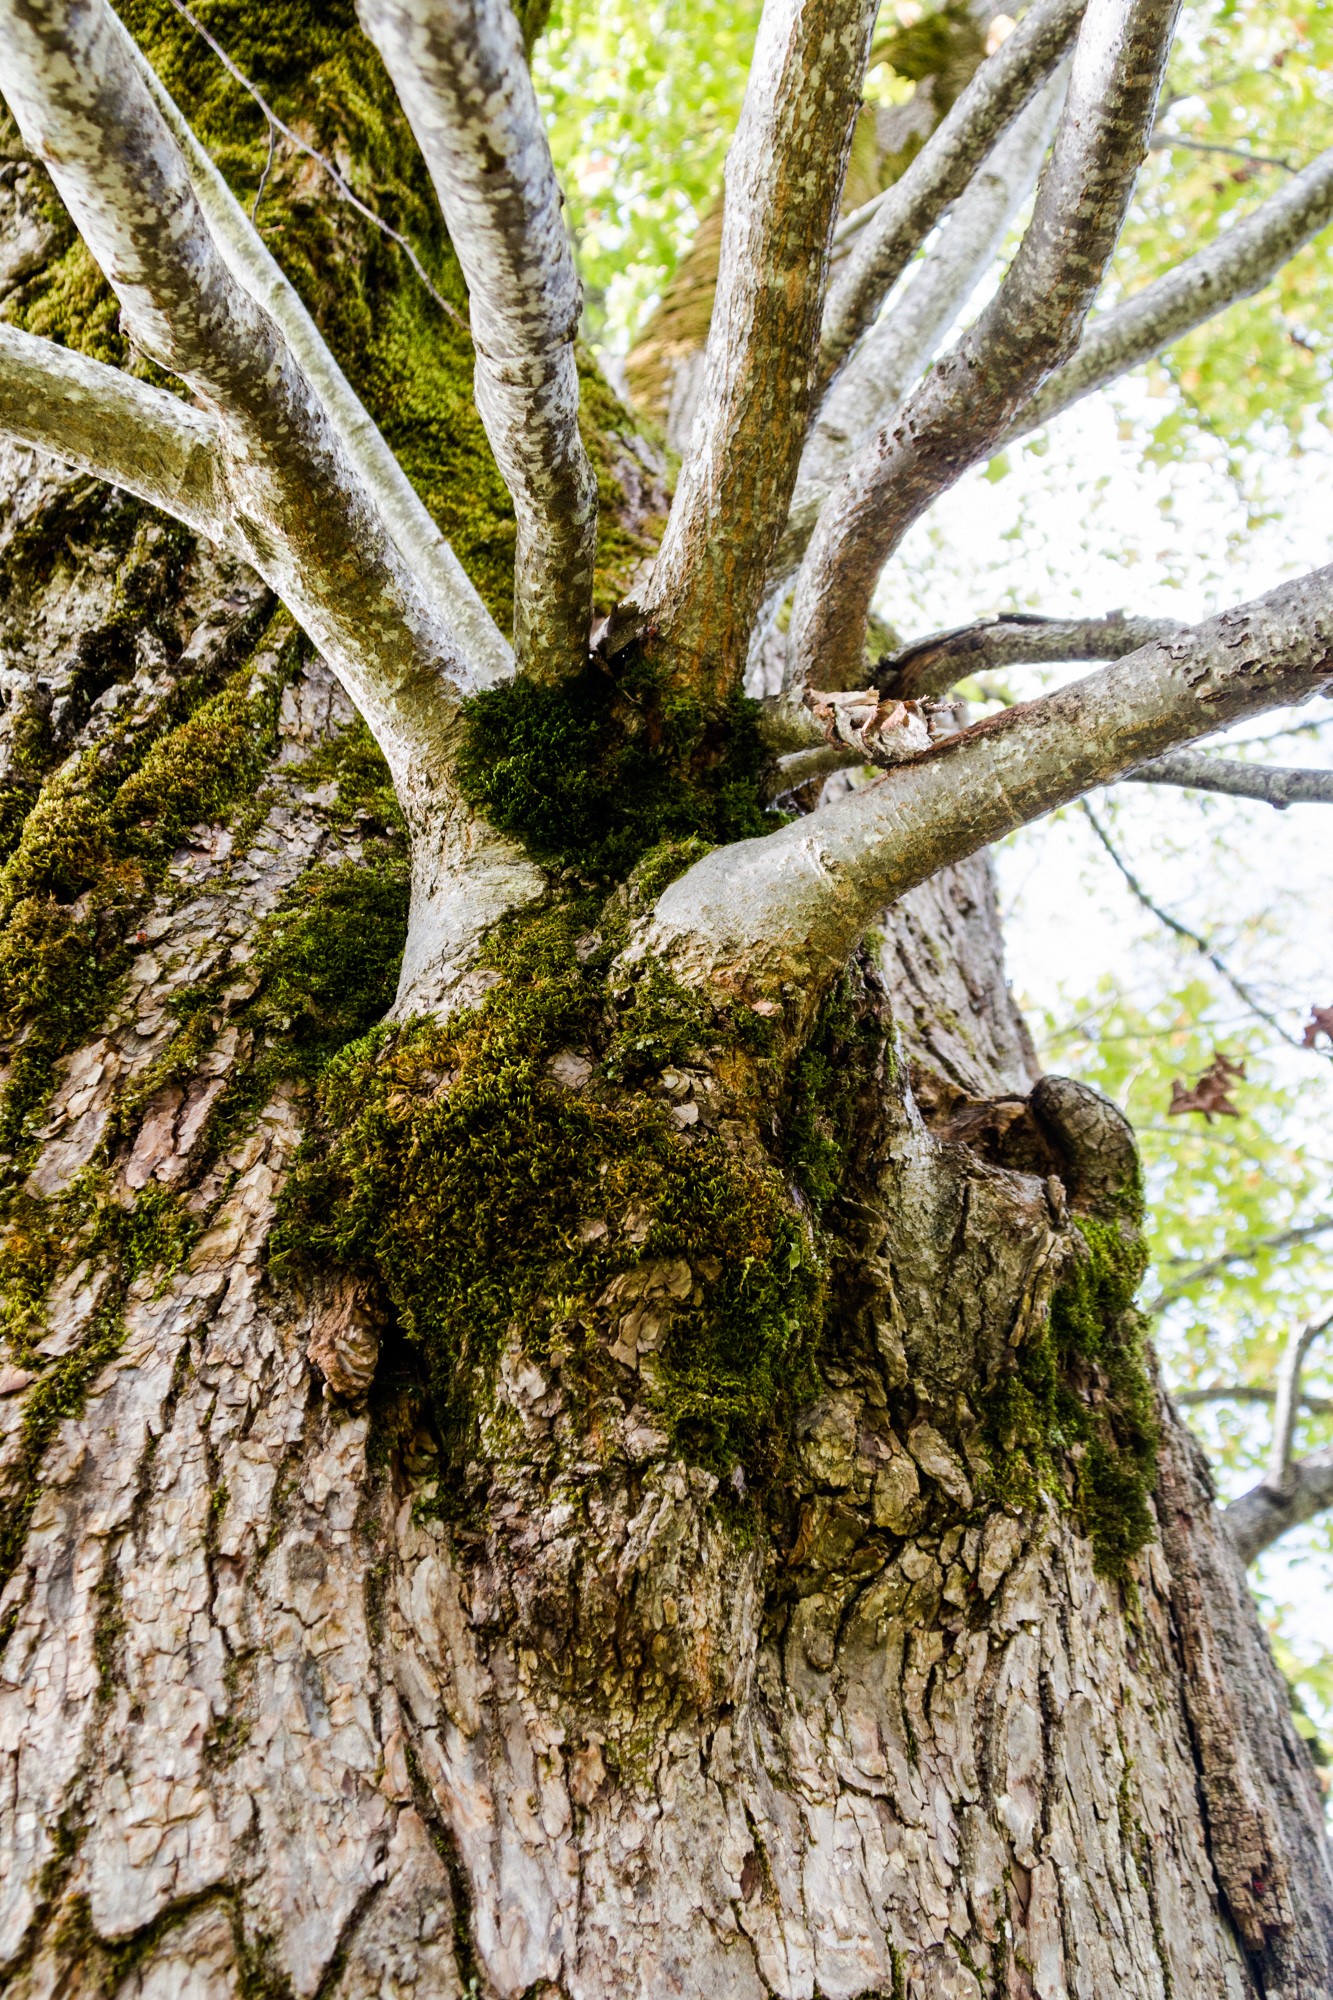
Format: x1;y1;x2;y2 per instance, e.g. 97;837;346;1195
791;0;1177;686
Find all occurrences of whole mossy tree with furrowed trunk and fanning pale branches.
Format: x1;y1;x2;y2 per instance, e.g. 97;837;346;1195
0;0;1333;1996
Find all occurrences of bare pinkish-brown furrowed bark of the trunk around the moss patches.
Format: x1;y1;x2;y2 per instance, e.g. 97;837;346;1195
0;524;1329;2000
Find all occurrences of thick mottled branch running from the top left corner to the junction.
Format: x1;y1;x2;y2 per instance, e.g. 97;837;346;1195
0;0;498;812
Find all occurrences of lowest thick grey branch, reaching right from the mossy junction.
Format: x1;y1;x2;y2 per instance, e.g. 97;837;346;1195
640;568;1333;1024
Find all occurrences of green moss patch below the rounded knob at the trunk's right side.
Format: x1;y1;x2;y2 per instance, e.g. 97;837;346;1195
983;1216;1157;1576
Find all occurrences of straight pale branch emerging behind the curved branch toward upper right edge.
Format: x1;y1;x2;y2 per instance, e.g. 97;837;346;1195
1003;146;1333;442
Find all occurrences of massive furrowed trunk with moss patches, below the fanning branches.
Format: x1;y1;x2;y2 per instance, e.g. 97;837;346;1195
0;19;1333;2000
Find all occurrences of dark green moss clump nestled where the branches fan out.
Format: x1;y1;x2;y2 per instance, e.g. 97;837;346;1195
456;666;773;882
